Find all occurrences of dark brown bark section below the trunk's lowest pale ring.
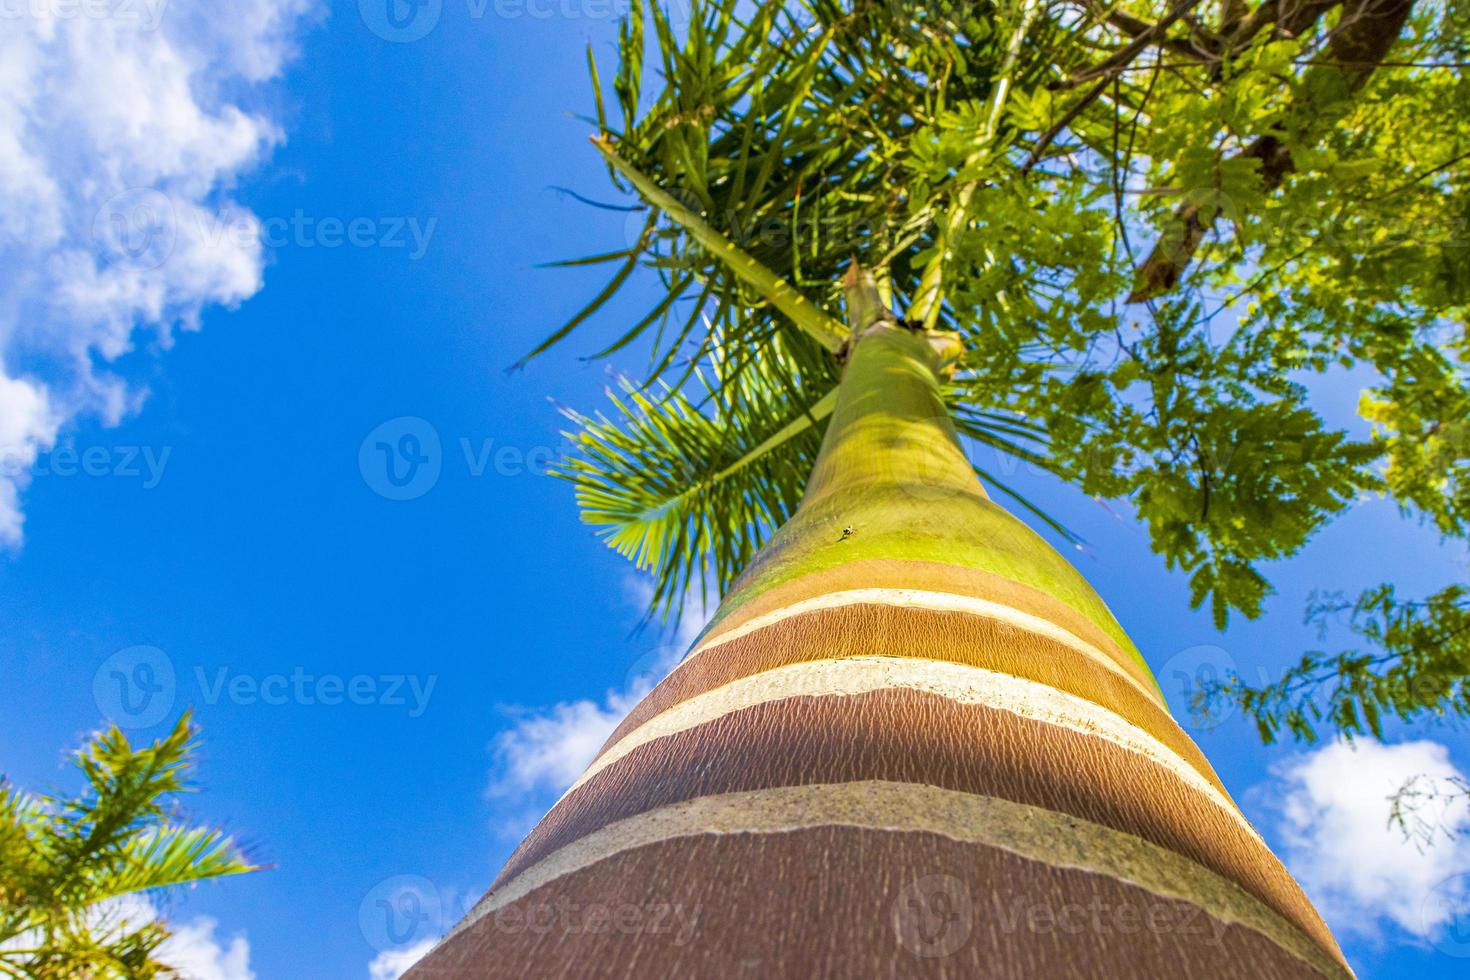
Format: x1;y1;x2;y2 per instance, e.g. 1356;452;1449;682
410;826;1322;980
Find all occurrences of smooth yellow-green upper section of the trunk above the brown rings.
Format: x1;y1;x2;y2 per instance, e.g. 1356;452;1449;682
716;320;1147;687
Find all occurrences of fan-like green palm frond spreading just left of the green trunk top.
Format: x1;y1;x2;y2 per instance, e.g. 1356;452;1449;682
557;340;836;625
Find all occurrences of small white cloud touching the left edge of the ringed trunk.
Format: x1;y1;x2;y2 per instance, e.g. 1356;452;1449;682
488;579;709;836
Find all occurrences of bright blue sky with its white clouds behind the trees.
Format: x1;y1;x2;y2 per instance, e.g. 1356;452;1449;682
0;0;1470;980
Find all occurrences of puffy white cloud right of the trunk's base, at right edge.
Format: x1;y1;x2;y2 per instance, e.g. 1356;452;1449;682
1263;741;1470;940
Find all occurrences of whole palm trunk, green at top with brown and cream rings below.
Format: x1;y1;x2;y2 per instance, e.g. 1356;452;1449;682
409;312;1351;980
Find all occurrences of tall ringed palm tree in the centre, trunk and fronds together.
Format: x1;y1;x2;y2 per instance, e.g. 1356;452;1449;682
409;0;1411;980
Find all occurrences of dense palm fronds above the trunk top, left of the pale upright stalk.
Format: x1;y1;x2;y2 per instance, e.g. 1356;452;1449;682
531;0;1061;386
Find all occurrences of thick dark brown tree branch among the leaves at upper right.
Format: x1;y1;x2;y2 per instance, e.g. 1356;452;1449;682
1127;0;1414;303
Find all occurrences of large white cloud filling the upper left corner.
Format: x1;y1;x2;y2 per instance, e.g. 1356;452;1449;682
0;0;315;545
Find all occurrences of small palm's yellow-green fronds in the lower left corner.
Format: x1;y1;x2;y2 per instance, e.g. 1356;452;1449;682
0;716;256;980
